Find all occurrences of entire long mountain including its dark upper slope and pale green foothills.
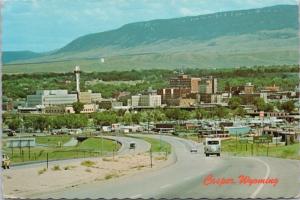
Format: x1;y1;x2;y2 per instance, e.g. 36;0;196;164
4;5;298;72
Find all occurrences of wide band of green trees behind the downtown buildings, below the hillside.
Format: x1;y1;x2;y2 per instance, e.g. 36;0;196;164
3;65;298;99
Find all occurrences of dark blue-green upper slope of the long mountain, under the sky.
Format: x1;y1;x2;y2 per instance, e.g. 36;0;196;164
55;5;298;54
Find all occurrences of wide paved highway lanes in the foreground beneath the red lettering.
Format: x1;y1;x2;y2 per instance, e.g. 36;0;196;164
28;136;300;199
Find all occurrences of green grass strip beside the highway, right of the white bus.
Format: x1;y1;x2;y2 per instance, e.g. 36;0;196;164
222;139;300;160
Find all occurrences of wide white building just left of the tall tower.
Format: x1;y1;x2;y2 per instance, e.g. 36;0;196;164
27;90;77;107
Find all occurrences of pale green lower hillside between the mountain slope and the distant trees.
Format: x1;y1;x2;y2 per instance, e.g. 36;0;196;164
3;50;298;73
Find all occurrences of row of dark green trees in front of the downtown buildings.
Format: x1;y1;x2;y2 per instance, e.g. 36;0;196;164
3;104;258;131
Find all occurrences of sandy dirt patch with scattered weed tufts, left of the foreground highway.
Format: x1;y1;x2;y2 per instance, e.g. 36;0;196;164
4;153;165;197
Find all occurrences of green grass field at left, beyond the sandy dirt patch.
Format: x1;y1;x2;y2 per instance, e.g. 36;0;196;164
3;136;120;163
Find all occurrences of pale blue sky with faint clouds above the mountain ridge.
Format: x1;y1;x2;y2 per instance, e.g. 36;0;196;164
1;0;297;52
